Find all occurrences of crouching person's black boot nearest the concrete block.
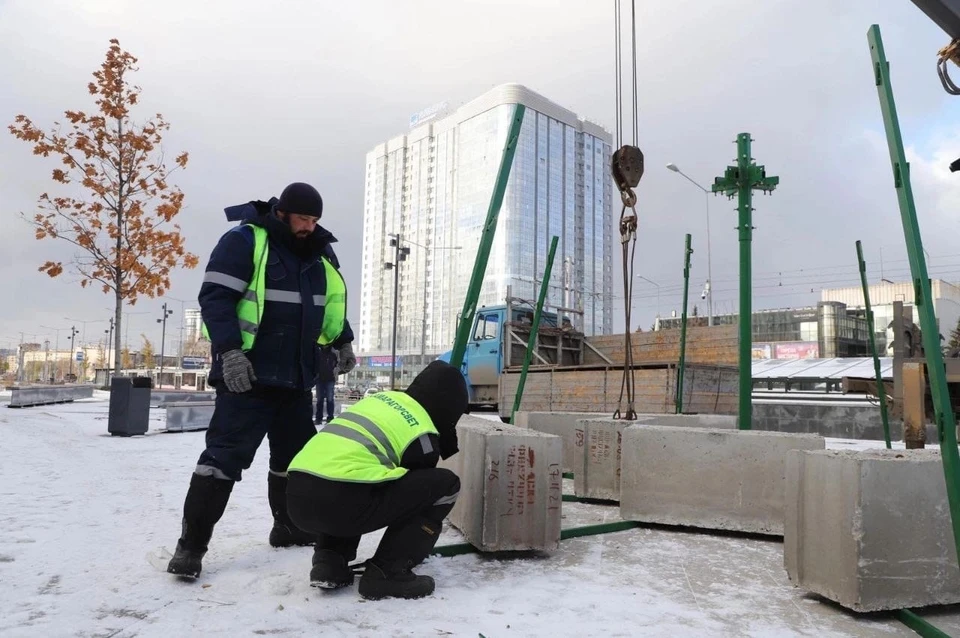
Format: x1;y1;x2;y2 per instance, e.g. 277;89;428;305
358;516;442;600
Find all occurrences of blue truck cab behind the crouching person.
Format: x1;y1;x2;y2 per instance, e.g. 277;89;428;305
438;305;572;406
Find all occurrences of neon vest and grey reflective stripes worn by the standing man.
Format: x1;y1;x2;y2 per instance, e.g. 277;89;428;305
201;224;347;352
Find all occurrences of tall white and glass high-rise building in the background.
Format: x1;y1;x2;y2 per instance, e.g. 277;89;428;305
353;84;613;356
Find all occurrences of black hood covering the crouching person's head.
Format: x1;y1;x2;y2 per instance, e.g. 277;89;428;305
406;360;470;459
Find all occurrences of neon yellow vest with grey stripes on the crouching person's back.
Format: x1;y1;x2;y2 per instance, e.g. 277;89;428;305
288;392;437;483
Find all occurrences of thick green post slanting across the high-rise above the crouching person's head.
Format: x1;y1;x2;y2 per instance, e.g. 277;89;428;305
450;104;526;368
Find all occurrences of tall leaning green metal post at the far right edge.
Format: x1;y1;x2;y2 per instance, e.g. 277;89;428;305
867;24;960;558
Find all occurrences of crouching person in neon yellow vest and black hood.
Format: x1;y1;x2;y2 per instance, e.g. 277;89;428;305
287;361;468;600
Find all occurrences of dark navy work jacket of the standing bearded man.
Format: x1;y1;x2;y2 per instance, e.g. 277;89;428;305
198;214;354;390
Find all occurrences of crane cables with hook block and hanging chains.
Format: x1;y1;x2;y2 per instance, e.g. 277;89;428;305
610;0;643;421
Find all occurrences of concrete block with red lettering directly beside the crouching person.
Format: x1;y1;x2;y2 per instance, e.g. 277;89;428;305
441;415;563;552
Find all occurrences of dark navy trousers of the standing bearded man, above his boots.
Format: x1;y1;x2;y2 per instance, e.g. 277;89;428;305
197;385;317;481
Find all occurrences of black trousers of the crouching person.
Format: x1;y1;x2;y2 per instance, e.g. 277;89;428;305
287;468;460;565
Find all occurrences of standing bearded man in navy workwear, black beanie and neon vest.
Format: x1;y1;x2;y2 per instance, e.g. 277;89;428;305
167;183;356;578
